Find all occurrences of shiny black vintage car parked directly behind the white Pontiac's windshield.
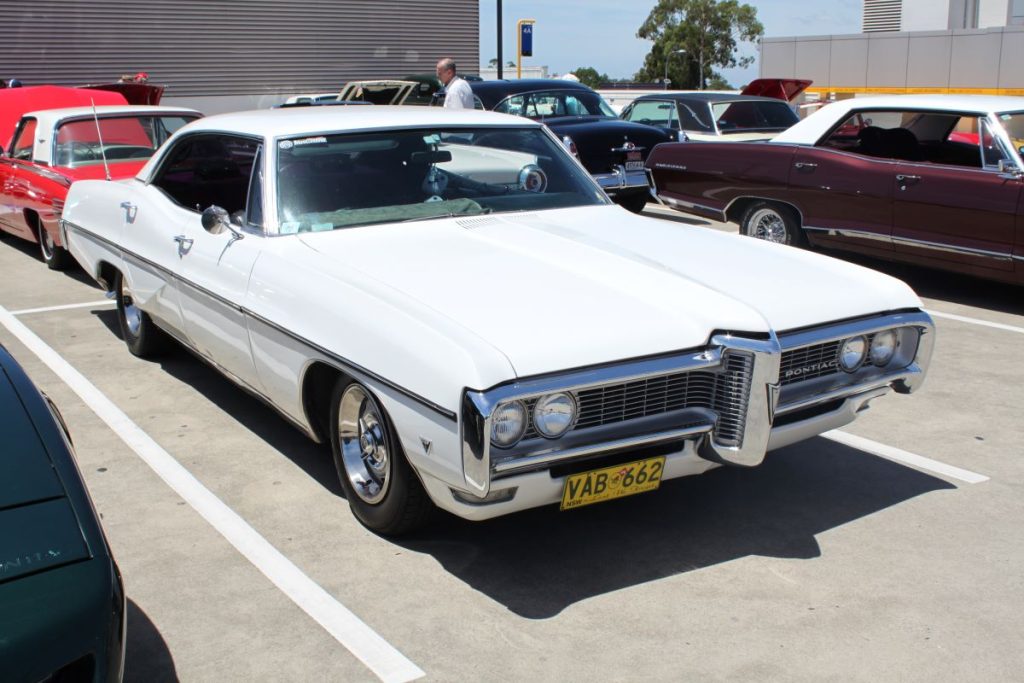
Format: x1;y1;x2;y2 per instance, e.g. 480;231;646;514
456;79;676;213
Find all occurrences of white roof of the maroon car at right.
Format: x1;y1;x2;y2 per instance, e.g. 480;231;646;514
772;94;1024;144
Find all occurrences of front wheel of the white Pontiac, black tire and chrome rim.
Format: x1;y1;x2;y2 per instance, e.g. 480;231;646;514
329;377;434;536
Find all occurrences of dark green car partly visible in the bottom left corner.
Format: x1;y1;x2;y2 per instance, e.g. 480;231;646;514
0;346;126;683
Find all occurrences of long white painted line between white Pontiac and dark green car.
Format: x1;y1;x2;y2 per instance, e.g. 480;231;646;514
0;306;426;683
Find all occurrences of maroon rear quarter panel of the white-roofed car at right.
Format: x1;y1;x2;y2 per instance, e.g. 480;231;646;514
647;142;797;220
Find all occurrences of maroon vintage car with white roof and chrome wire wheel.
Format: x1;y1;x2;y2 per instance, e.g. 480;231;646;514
647;95;1024;284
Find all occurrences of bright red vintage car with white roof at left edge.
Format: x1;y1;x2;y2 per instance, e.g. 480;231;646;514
0;86;201;270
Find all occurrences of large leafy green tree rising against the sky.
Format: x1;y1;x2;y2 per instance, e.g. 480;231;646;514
637;0;764;90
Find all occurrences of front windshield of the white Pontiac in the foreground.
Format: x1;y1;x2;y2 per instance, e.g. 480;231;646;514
276;127;607;234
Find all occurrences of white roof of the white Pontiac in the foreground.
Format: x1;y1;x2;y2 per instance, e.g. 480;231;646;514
181;104;541;137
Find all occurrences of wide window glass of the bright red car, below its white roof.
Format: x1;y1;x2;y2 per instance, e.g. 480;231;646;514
53;116;197;168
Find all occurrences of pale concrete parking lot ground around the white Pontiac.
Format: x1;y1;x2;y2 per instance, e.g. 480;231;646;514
0;208;1024;681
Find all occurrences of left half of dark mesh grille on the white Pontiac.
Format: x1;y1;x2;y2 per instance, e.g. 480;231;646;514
523;353;754;445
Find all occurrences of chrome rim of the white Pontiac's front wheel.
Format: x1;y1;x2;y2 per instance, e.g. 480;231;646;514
338;384;391;504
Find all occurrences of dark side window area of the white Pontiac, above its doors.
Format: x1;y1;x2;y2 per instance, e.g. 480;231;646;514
153;133;260;214
